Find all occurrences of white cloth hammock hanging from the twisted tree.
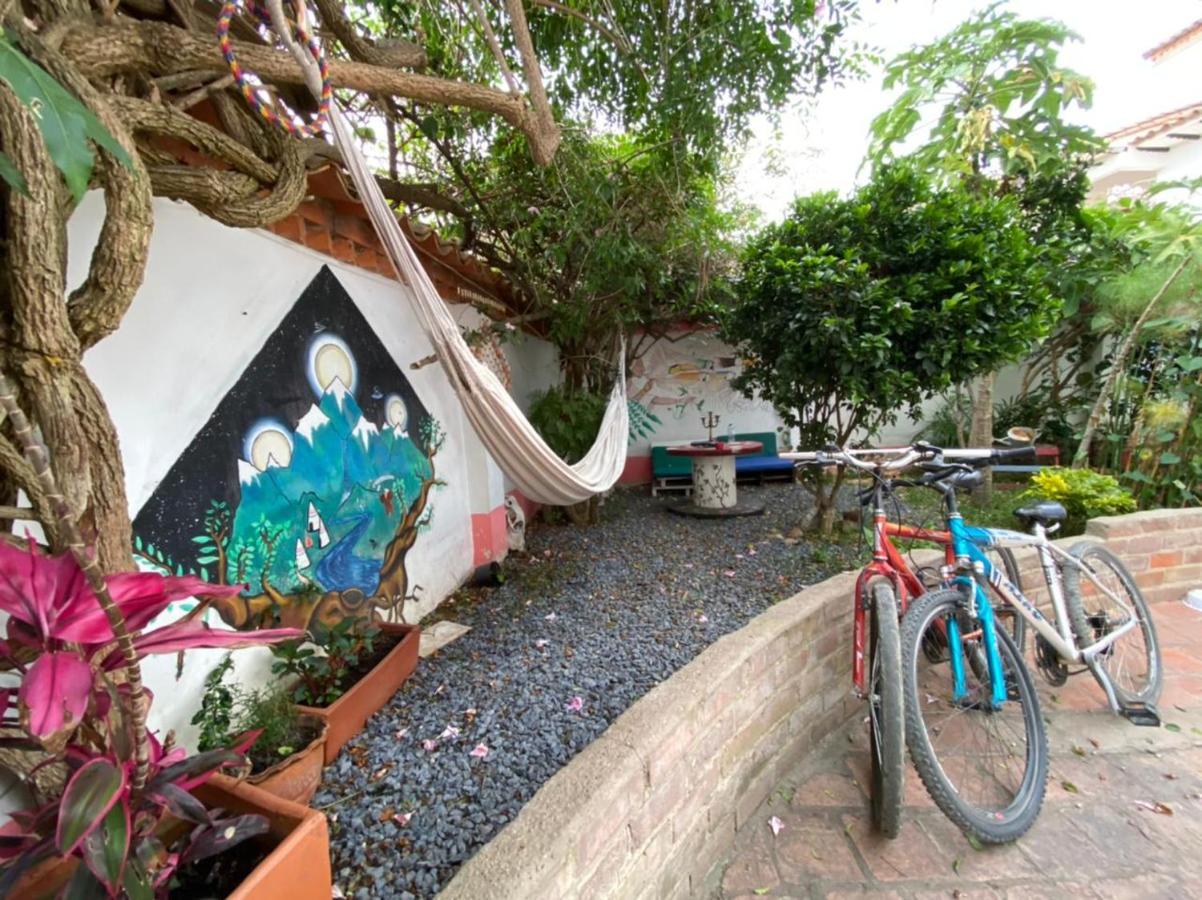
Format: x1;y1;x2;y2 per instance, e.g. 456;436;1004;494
268;0;630;506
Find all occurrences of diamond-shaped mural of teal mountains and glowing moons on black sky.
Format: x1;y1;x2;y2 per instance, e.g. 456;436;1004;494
133;268;444;628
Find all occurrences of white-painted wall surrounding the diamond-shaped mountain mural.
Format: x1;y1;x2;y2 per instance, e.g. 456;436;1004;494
69;192;512;743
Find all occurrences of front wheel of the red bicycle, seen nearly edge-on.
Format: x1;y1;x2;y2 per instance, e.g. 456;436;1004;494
868;582;905;838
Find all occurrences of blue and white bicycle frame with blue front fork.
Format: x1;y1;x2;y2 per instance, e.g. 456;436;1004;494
947;512;1138;707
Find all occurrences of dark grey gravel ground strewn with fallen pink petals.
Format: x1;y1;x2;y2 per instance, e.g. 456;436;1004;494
314;485;863;899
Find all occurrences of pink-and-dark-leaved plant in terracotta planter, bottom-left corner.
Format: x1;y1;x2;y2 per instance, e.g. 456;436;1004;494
0;375;331;900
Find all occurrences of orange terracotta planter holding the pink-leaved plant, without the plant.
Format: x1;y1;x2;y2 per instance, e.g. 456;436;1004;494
8;775;333;900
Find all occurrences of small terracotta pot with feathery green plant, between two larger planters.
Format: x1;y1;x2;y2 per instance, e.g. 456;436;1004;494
192;655;328;804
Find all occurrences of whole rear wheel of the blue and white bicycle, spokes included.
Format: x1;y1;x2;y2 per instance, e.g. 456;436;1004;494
1063;541;1161;703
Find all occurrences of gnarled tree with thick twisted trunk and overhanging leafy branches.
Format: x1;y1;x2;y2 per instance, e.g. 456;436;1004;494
0;0;855;570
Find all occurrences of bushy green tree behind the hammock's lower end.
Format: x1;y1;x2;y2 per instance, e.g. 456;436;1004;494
456;131;739;395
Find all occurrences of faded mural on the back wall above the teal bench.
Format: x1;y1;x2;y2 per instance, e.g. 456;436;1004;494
626;341;748;441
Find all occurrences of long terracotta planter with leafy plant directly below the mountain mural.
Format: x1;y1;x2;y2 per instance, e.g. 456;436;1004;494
272;618;421;765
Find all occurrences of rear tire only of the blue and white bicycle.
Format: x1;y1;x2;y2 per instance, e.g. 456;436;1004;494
1061;541;1164;704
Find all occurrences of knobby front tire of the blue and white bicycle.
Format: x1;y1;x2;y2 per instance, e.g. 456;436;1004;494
902;589;1048;844
